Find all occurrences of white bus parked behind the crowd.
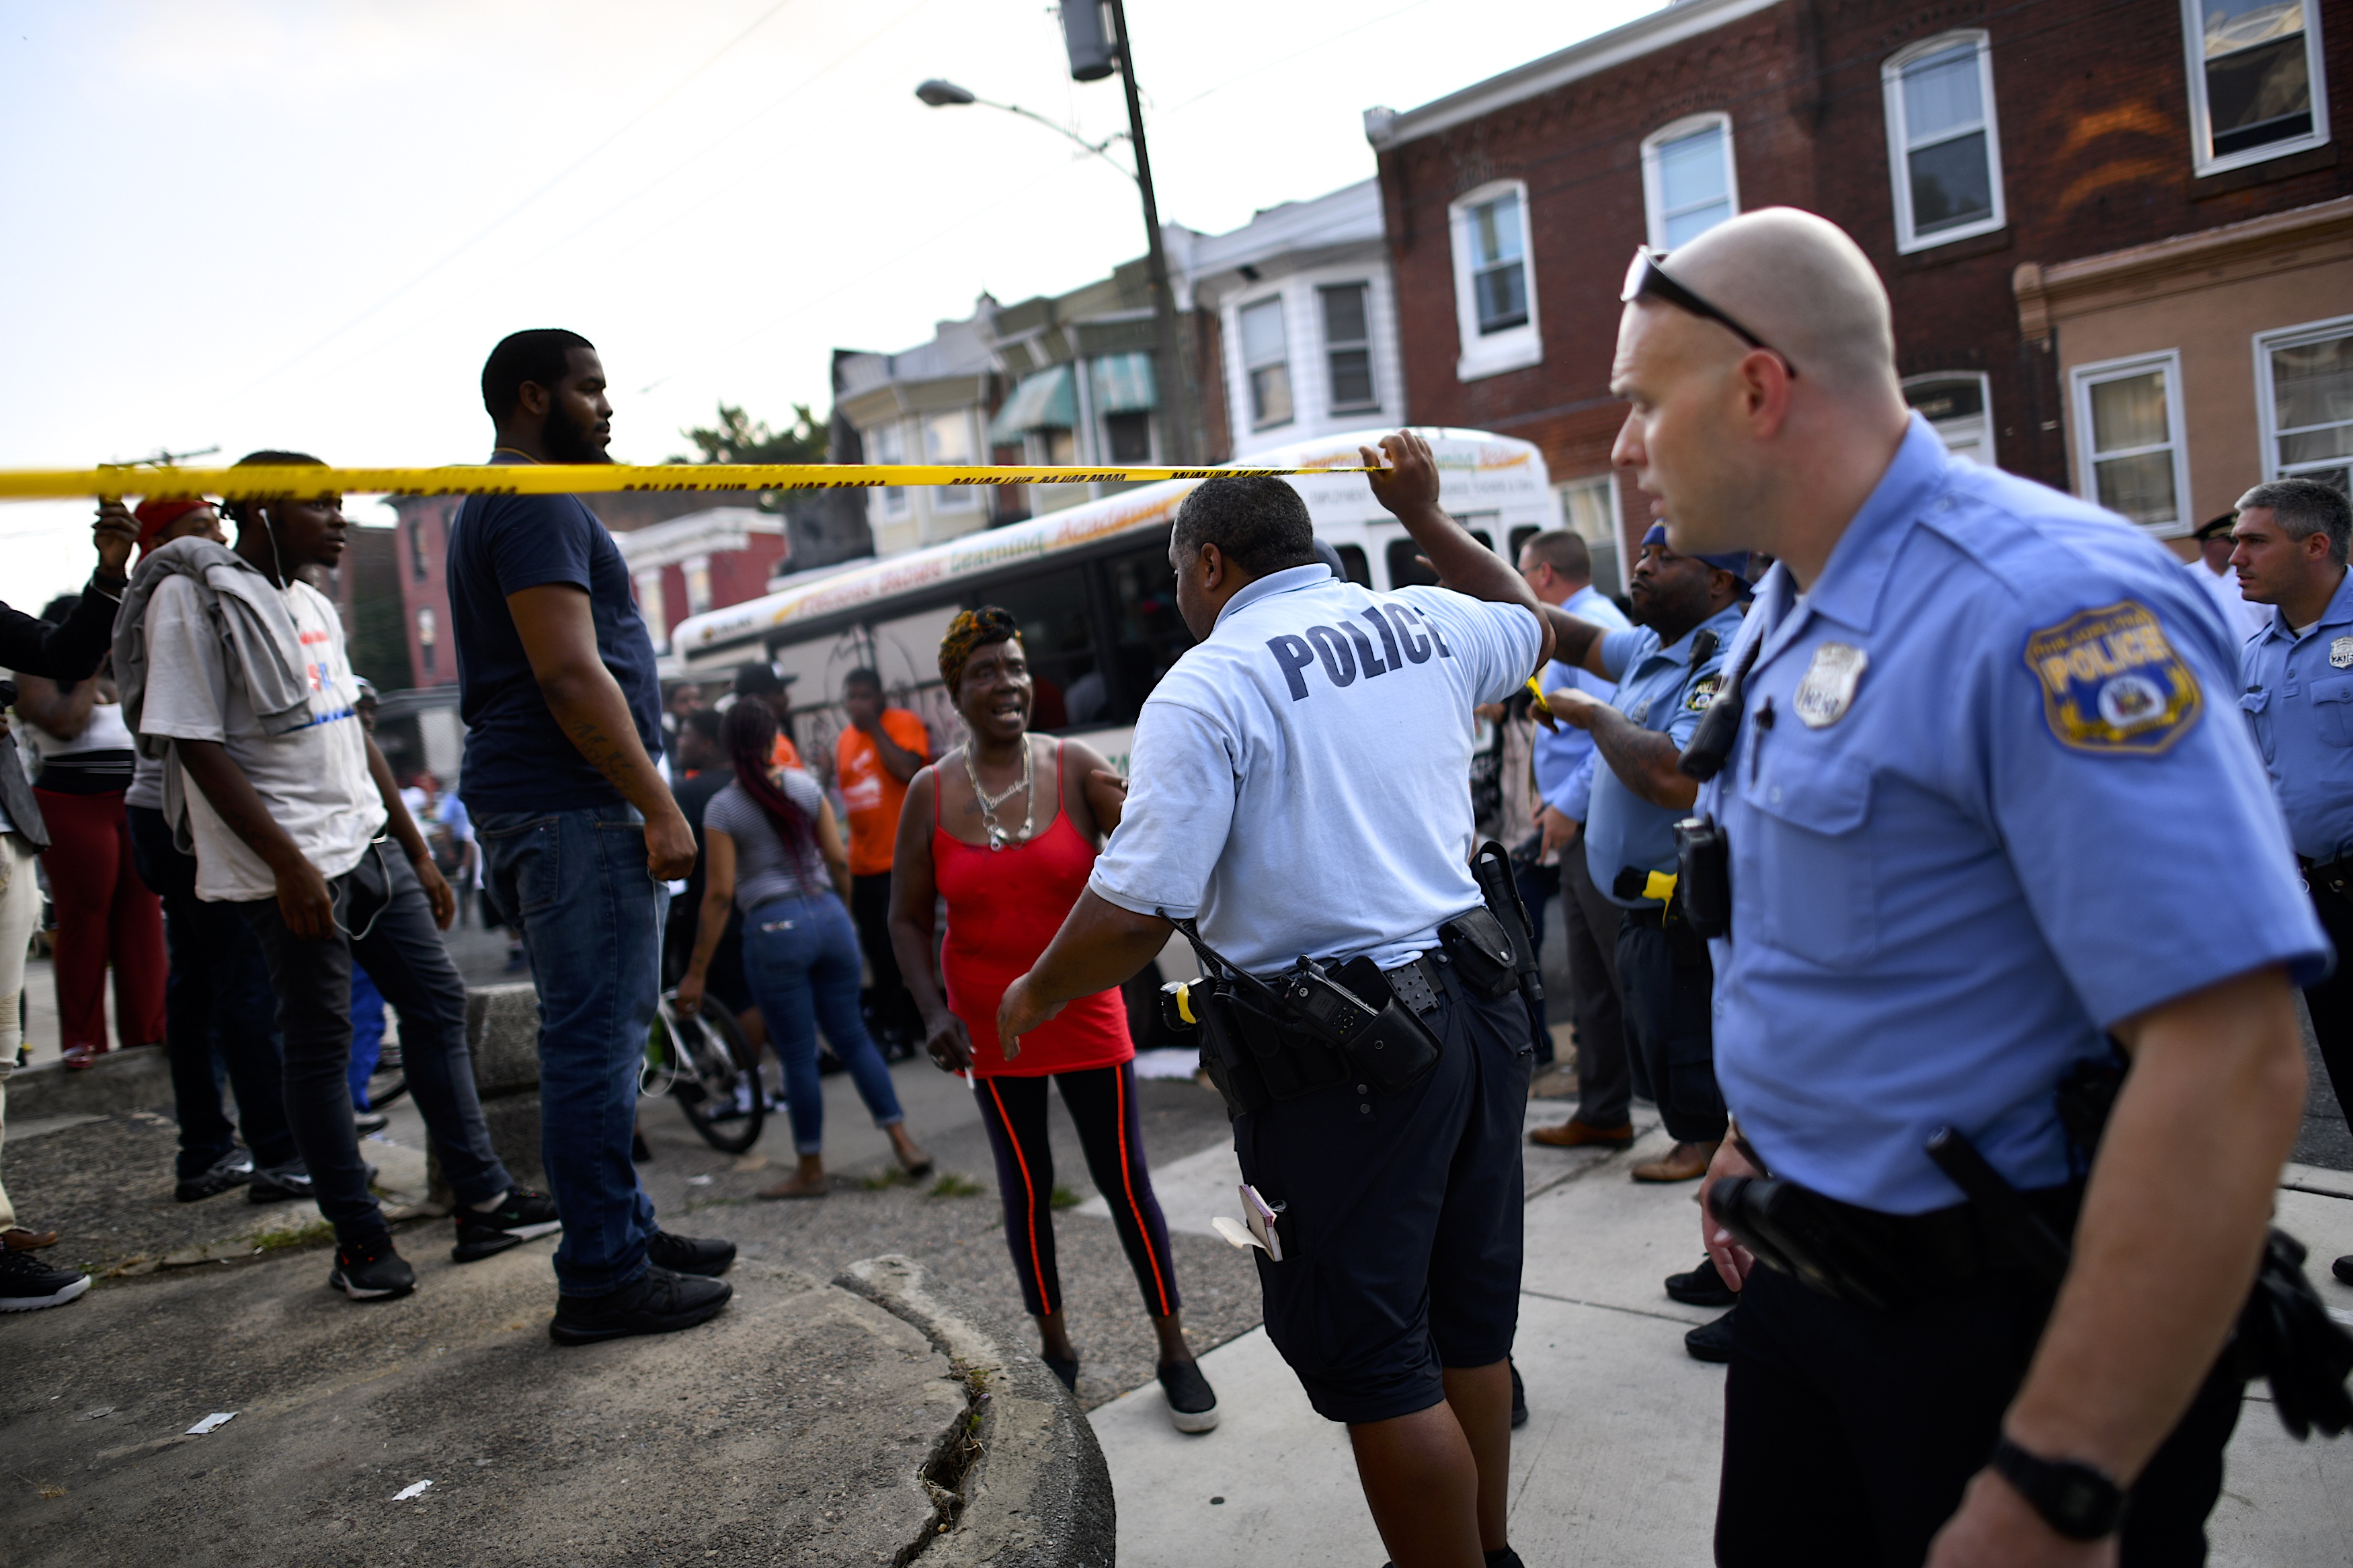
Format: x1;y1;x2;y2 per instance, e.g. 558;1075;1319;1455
671;430;1560;780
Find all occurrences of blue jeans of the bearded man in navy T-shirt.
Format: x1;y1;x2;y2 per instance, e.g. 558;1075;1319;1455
473;804;671;1295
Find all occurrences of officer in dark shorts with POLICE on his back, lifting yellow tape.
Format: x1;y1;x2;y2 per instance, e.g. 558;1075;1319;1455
998;451;1551;1568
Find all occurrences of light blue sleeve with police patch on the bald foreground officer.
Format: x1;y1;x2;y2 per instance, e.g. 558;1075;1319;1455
1977;585;2329;1028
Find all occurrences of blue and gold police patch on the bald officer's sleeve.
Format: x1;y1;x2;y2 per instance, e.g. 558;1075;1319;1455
2026;600;2205;757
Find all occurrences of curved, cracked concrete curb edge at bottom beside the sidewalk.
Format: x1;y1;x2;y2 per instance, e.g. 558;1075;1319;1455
833;1255;1118;1568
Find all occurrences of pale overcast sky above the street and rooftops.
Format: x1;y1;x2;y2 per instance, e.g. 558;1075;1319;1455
0;0;1652;609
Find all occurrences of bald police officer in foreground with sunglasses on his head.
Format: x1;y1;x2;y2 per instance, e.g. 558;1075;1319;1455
1560;209;2329;1568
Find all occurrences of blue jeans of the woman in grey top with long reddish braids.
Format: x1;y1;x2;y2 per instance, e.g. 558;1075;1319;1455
744;893;906;1154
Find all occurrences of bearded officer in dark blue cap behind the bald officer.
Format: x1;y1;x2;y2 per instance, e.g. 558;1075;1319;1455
1546;524;1749;1182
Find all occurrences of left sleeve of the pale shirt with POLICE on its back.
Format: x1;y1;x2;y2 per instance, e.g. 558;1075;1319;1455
1087;698;1240;919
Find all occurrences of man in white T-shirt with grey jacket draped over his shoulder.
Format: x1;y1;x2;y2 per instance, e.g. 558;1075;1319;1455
116;452;558;1300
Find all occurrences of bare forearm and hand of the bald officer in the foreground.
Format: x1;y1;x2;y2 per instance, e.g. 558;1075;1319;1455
1929;968;2304;1568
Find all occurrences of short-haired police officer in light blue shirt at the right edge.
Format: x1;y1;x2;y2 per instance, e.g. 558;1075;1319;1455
2196;480;2353;1284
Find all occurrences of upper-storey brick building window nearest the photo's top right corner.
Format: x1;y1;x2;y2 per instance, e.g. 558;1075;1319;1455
2182;0;2329;174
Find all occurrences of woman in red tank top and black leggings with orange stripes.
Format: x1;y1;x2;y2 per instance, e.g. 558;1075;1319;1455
892;606;1217;1432
